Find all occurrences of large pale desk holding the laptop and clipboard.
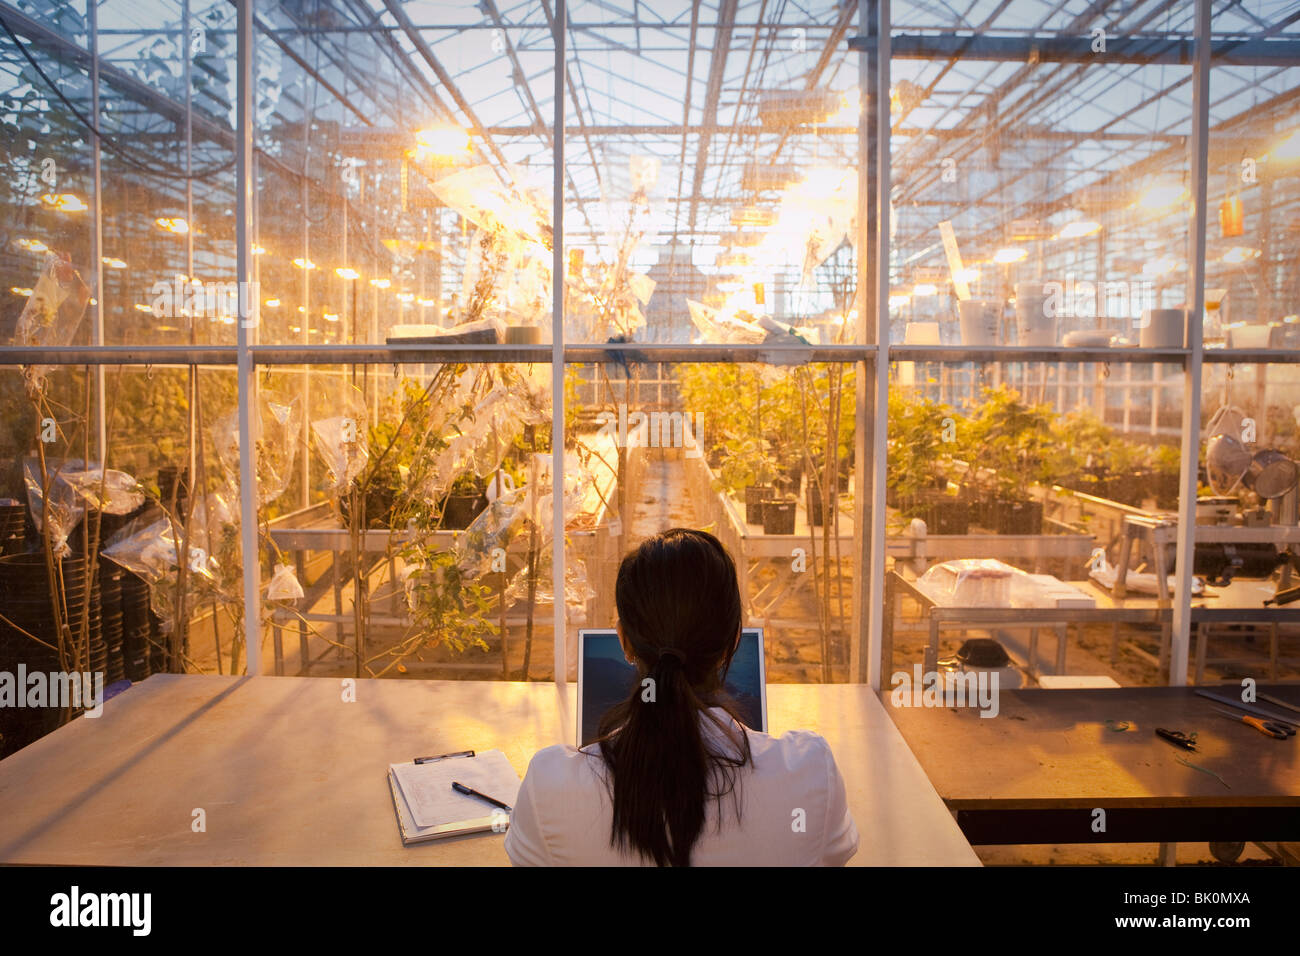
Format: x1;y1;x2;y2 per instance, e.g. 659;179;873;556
0;674;979;866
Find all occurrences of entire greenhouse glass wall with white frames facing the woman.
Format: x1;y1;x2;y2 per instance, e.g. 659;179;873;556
0;0;1300;752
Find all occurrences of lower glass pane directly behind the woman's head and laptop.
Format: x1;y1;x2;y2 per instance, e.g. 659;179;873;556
566;363;861;683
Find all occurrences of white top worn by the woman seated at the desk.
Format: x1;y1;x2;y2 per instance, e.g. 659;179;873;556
506;709;858;866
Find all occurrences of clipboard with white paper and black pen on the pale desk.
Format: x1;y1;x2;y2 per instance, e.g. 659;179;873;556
389;750;520;847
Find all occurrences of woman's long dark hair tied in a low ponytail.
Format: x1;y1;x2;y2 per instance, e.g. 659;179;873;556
599;528;750;866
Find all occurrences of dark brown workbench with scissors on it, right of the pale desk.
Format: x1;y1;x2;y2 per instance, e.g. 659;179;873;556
884;684;1300;844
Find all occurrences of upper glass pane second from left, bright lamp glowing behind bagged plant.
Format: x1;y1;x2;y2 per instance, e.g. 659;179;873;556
254;3;554;345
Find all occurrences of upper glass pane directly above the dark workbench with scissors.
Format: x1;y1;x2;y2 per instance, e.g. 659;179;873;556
889;4;1192;349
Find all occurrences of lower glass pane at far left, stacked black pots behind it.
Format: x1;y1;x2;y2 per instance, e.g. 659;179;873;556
0;364;223;754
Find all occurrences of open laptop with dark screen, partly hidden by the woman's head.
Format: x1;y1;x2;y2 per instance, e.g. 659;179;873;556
577;627;767;747
